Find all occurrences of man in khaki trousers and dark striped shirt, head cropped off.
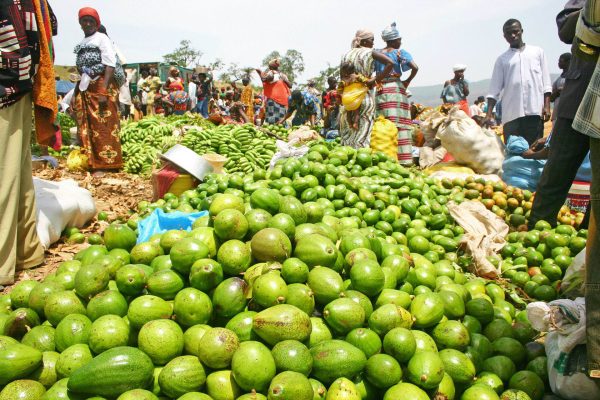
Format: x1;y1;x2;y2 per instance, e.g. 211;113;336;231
0;0;56;286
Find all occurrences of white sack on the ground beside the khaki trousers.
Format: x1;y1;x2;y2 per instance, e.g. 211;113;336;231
33;178;96;249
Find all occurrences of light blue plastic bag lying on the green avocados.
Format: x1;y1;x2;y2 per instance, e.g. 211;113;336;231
137;208;208;243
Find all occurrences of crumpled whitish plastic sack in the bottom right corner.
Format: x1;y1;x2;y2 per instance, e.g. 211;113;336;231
527;297;600;400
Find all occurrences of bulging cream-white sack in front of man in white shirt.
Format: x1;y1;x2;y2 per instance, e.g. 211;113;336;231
437;107;504;174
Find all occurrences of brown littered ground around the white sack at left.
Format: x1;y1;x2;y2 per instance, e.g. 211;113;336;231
4;164;152;292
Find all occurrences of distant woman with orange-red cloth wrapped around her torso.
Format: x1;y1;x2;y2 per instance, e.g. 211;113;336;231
256;58;292;124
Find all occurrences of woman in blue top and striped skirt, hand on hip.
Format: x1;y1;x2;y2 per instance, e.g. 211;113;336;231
375;22;419;165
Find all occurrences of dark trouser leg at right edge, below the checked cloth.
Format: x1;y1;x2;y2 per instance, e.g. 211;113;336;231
585;139;600;377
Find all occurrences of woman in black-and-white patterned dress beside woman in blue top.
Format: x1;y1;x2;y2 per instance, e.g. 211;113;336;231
339;30;394;148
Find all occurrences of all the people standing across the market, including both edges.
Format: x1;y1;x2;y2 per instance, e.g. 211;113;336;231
0;0;600;384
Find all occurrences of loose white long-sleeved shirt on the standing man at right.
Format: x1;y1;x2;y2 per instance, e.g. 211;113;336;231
487;45;552;124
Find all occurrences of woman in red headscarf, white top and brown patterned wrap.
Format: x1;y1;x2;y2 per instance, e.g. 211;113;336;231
73;7;125;171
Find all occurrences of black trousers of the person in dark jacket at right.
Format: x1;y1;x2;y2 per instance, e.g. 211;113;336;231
529;118;590;228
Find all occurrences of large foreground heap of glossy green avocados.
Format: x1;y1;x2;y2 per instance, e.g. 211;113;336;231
0;144;564;400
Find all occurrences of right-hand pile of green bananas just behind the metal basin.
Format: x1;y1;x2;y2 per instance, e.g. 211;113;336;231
181;124;276;173
